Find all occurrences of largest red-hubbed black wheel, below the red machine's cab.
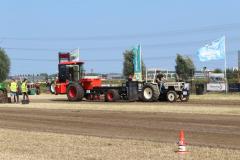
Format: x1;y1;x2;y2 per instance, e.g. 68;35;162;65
67;83;84;101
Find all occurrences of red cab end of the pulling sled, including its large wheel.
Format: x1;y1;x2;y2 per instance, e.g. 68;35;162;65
53;53;102;99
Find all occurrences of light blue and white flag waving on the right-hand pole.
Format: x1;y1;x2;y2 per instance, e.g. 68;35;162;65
197;36;226;62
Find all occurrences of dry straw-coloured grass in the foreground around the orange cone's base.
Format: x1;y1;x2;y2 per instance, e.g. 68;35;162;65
0;129;240;160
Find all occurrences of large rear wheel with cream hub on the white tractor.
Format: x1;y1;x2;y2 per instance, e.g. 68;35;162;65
141;84;160;102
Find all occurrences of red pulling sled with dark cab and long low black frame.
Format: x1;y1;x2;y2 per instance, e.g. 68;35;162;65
50;53;137;102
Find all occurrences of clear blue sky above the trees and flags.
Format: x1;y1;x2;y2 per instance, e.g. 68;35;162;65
0;0;240;74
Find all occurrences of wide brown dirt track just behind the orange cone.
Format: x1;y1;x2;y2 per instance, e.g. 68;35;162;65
0;102;240;149
